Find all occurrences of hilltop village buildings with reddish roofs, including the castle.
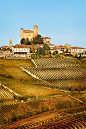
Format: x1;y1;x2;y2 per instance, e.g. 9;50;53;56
0;25;85;57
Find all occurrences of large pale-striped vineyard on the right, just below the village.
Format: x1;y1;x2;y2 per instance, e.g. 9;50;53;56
25;58;86;89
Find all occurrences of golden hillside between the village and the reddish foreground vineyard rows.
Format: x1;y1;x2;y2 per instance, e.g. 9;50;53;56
0;58;86;124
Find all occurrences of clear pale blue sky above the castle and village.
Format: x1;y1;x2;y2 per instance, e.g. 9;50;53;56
0;0;86;48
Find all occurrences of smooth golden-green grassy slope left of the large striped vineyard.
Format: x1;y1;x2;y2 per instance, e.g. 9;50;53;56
0;59;58;97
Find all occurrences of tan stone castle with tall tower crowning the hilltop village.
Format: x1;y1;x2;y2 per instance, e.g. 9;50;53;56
20;25;38;41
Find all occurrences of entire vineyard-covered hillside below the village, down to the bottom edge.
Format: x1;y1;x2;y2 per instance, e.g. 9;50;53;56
0;58;86;126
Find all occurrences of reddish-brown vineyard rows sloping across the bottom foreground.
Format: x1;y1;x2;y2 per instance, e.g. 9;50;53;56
1;106;86;129
